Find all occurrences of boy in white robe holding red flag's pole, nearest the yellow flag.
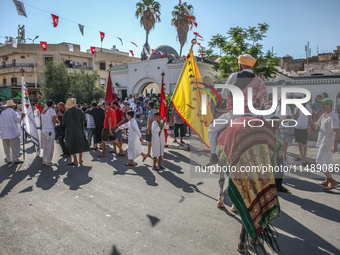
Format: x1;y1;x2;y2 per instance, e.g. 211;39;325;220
151;112;169;171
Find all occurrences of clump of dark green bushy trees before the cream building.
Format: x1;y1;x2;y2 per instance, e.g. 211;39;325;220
41;61;105;104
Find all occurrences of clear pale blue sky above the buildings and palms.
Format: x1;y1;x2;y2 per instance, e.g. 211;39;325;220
0;0;340;59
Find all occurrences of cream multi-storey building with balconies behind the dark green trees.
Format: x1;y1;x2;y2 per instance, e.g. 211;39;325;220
0;42;140;102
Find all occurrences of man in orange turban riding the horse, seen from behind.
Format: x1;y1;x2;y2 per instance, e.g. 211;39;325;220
208;54;267;163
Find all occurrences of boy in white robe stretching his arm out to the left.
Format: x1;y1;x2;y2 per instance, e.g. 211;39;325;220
116;111;148;166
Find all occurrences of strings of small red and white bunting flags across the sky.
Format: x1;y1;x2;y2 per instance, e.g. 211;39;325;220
12;0;204;59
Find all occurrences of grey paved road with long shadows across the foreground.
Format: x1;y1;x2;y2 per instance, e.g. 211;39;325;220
0;138;340;255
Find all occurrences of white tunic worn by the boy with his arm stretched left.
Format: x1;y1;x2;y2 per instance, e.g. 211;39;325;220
119;119;142;160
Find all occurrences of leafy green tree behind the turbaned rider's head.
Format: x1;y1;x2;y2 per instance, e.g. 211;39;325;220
214;23;279;78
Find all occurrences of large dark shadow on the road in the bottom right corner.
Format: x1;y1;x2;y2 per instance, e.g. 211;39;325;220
273;210;339;255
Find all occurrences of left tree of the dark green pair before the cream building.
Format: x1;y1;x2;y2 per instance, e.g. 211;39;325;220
41;61;70;103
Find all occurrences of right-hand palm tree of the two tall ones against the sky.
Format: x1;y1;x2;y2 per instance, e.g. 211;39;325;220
171;2;196;56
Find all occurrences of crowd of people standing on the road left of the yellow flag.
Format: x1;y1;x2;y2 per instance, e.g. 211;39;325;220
0;91;185;170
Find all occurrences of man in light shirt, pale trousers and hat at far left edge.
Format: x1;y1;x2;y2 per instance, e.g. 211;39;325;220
0;100;25;164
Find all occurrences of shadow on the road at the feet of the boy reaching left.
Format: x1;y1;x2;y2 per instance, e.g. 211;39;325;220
113;165;158;186
